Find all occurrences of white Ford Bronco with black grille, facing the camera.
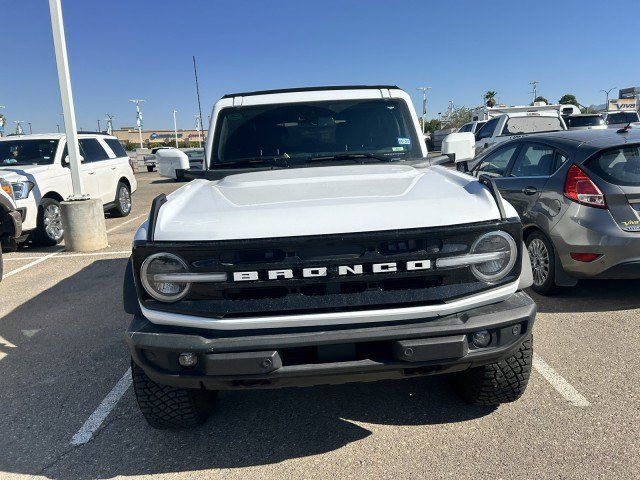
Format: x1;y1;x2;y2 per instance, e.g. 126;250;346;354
124;86;536;428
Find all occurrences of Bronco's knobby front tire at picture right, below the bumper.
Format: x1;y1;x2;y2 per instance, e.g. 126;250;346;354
456;337;533;406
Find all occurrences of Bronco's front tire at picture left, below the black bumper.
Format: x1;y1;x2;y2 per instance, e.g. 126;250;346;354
131;361;217;430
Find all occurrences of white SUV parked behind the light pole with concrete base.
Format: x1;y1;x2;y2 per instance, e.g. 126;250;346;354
0;134;137;245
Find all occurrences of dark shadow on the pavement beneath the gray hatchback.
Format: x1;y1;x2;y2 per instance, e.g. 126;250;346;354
527;280;640;313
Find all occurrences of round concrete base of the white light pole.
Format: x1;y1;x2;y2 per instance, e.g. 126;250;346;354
60;199;108;252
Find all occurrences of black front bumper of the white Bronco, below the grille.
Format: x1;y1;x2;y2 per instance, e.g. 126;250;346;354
126;292;536;390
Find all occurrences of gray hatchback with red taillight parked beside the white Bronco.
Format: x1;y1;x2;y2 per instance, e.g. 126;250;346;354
471;129;640;294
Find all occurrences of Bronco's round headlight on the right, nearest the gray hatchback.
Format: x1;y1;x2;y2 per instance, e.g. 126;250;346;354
471;231;518;283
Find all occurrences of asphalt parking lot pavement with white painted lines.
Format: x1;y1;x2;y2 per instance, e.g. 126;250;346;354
0;172;640;479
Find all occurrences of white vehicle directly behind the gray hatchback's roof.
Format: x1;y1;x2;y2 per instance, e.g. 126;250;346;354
476;110;567;155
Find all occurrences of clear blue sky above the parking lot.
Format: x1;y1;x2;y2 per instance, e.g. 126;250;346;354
0;0;640;132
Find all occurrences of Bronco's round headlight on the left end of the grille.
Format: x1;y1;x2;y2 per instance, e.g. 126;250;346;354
140;253;191;302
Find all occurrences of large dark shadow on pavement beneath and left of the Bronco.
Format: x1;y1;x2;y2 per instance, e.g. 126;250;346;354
0;259;492;479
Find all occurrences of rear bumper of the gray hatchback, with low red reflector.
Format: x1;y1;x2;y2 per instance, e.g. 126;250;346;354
550;204;640;279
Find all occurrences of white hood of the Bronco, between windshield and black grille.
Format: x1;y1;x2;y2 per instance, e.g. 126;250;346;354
154;164;508;241
